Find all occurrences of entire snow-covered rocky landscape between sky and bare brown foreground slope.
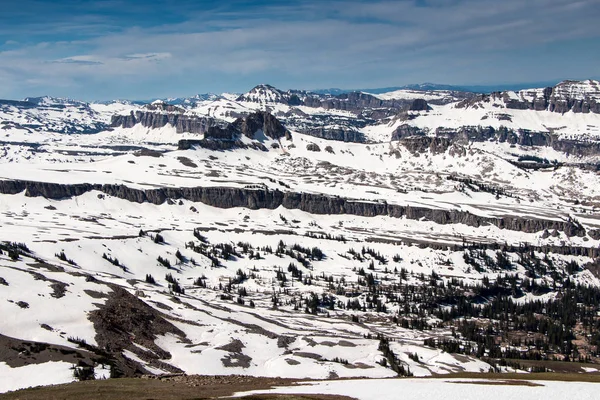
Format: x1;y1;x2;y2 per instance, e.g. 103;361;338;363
0;80;600;392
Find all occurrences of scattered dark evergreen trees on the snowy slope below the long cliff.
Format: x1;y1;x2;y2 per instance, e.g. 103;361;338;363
5;229;600;375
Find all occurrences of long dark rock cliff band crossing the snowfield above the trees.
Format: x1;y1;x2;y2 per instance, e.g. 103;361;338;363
0;180;586;236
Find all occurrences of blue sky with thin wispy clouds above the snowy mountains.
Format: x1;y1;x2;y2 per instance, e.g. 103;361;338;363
0;0;600;100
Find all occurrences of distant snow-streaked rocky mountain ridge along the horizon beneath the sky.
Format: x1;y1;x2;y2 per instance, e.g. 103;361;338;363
0;80;600;148
